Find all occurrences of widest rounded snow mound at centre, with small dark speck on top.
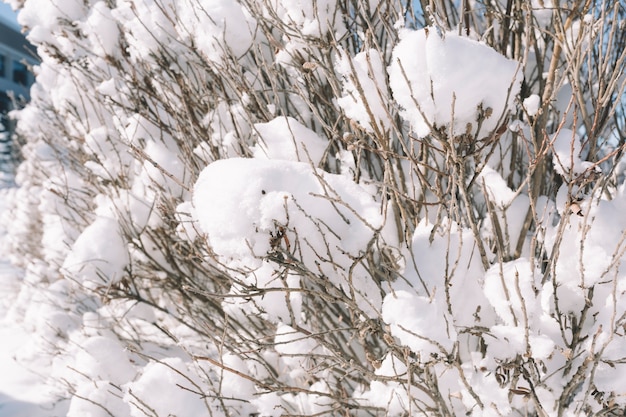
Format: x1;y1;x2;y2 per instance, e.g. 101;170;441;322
193;158;382;266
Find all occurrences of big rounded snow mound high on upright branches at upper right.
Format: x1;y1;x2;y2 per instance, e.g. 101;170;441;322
389;28;522;137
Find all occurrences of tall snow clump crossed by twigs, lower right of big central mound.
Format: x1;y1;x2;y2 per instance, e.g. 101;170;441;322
382;220;495;362
